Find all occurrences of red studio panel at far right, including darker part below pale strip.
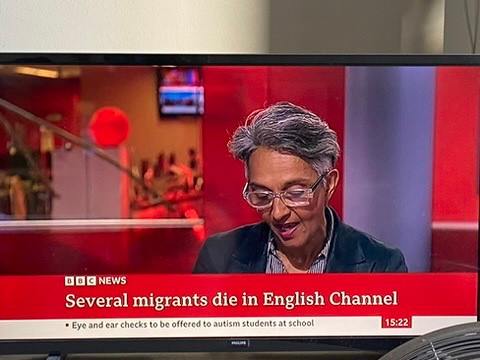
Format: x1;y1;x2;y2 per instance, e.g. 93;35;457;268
432;67;480;271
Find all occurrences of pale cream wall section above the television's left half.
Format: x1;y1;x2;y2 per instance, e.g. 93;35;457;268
0;0;269;53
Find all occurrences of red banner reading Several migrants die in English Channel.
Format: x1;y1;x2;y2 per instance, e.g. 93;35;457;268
0;273;477;320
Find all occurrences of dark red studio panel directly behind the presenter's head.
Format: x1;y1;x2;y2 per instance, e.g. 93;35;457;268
202;66;345;234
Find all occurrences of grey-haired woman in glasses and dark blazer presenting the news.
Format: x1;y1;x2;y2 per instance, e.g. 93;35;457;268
193;102;407;273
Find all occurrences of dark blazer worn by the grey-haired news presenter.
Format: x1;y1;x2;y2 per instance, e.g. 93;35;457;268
193;209;407;274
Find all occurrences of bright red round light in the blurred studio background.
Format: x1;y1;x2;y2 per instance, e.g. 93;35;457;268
89;106;130;147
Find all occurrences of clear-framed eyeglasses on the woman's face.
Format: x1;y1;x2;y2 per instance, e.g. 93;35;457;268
243;171;329;210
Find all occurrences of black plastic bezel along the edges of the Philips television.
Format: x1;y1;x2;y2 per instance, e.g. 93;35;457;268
0;52;480;355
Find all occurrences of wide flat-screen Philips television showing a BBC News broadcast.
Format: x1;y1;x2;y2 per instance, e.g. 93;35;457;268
0;53;480;354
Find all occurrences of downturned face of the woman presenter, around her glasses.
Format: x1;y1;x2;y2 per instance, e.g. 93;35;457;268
247;147;338;249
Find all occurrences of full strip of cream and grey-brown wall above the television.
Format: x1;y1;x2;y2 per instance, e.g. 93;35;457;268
0;0;474;53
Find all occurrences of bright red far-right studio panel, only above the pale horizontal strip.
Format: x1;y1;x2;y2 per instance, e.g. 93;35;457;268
433;67;480;222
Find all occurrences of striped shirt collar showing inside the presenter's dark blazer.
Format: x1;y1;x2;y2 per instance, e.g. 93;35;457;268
265;206;335;274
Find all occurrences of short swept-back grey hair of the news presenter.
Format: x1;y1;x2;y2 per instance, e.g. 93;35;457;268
228;102;340;175
